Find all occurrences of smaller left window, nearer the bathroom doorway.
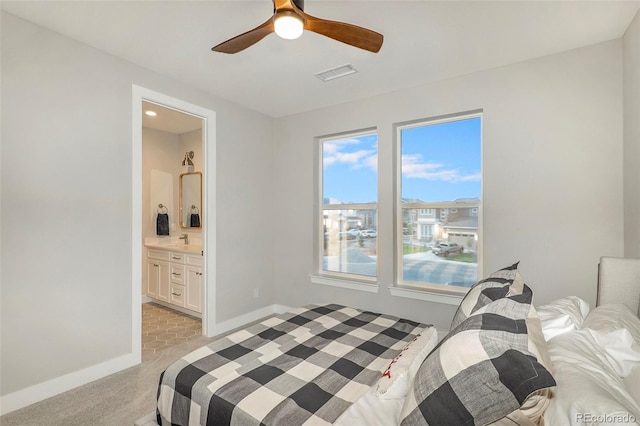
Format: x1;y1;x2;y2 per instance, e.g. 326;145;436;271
318;132;378;281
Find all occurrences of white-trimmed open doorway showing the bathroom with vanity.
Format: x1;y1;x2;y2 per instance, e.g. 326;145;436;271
132;86;215;359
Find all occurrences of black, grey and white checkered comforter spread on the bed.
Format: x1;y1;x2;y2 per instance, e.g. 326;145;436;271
157;305;427;426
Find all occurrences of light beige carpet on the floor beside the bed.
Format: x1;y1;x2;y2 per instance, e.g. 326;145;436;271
0;336;213;426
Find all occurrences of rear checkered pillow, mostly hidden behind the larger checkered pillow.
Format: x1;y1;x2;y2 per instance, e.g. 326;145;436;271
450;262;524;330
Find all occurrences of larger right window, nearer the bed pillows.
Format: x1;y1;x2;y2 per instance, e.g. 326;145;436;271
396;114;482;294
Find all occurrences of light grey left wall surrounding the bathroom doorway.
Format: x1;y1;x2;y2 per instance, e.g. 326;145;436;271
0;12;274;402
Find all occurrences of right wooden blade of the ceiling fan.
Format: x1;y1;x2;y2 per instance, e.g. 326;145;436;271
296;10;384;53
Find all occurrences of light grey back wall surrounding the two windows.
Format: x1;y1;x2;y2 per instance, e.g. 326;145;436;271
274;40;623;329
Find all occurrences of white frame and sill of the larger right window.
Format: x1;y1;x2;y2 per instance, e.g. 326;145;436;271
390;110;484;298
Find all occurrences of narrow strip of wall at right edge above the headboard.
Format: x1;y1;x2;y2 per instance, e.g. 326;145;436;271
623;12;640;257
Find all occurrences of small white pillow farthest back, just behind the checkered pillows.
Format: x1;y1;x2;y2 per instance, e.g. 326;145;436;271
536;296;590;341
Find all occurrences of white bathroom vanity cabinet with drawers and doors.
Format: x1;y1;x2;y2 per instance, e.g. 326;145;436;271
146;248;202;313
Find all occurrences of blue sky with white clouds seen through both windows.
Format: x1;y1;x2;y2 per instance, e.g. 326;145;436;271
323;118;481;203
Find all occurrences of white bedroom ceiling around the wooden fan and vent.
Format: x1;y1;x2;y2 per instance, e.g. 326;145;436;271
0;0;640;117
